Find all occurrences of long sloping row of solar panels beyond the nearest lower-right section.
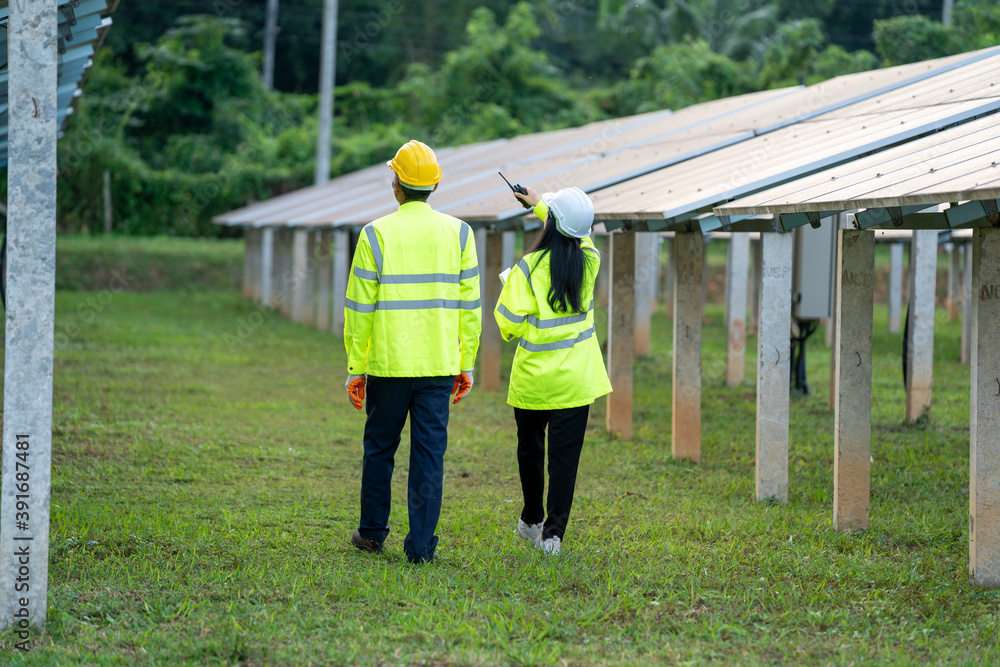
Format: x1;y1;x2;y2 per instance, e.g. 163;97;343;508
216;43;1000;231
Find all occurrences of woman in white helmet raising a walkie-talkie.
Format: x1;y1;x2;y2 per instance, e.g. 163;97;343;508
494;188;611;555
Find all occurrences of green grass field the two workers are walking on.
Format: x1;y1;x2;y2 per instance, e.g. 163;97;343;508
0;237;1000;665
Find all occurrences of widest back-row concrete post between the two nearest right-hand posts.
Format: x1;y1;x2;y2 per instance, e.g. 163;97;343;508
906;229;938;422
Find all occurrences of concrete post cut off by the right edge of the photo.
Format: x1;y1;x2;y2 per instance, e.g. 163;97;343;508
969;227;1000;587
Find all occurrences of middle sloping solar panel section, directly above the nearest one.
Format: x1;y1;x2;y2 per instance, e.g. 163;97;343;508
593;48;1000;230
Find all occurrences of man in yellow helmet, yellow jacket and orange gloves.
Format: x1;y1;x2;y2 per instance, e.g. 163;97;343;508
344;141;482;563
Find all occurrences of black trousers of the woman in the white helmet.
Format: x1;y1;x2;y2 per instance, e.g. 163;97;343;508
514;405;590;539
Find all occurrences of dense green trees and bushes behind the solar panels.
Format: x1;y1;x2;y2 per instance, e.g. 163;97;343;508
52;0;1000;236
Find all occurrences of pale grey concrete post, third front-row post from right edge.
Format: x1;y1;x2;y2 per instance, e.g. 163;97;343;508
756;232;792;502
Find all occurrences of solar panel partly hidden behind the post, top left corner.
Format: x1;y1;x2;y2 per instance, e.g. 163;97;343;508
0;0;118;166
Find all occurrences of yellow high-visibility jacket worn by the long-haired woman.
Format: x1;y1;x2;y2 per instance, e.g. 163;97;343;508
493;203;611;410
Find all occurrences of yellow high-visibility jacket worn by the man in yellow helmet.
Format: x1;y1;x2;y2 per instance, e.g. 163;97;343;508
344;202;482;377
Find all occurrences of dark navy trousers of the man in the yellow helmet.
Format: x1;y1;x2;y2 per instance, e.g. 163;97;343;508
358;375;455;562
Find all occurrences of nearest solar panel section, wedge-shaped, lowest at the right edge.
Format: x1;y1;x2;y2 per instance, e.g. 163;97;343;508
715;111;1000;215
